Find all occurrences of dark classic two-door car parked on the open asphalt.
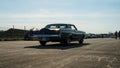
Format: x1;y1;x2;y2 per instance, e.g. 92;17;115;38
32;24;85;45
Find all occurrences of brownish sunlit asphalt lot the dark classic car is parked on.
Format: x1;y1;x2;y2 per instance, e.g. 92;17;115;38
0;39;120;68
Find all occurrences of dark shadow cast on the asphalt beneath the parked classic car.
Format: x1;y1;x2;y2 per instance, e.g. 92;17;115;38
24;43;90;50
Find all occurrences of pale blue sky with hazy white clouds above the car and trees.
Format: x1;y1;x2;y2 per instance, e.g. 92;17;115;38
0;0;120;33
